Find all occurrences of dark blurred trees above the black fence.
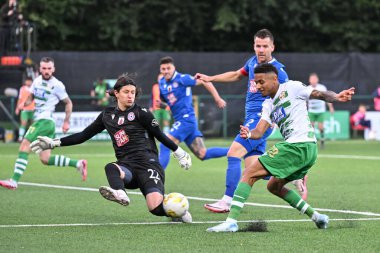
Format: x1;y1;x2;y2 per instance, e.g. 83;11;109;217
19;0;380;52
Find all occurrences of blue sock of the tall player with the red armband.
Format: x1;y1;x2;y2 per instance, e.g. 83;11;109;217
224;157;241;198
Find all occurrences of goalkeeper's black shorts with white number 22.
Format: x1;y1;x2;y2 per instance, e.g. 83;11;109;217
117;161;165;196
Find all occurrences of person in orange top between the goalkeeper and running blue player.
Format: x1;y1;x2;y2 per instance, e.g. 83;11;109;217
150;74;171;134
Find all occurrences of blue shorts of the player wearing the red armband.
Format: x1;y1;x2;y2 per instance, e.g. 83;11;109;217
234;118;273;158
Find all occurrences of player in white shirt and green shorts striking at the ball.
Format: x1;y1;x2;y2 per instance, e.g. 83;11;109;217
207;64;355;232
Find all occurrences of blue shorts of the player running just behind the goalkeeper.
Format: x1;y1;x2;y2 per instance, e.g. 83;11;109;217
169;117;203;146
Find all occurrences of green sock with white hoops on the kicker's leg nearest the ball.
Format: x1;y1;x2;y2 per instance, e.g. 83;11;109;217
227;182;252;221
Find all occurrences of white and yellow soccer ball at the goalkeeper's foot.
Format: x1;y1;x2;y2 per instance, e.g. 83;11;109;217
164;192;189;218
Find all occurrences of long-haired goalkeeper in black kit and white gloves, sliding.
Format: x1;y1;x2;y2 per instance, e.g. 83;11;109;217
30;74;192;223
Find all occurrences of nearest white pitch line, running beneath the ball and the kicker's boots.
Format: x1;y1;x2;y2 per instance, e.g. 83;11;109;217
0;218;380;228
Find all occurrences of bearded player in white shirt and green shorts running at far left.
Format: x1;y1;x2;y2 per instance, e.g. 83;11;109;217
0;57;87;190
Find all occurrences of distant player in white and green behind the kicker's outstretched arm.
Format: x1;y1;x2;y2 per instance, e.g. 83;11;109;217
308;73;334;148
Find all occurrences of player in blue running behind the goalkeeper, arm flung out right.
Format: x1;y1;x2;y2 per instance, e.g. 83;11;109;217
159;56;228;169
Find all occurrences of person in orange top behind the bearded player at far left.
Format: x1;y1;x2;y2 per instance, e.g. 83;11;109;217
15;77;35;142
